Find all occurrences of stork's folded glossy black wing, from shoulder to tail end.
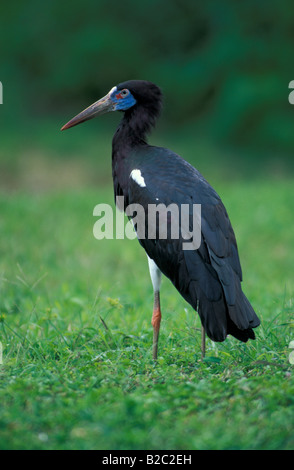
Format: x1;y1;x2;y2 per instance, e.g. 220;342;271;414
128;147;257;341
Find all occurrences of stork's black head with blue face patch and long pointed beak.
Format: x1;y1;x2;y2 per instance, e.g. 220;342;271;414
61;80;161;131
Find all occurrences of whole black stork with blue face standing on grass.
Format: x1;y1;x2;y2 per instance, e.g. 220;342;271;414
62;80;260;359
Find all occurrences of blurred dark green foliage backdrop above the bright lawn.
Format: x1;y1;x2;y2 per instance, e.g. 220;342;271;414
0;0;294;191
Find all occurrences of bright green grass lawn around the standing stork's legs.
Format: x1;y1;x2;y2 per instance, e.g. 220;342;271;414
0;180;294;450
